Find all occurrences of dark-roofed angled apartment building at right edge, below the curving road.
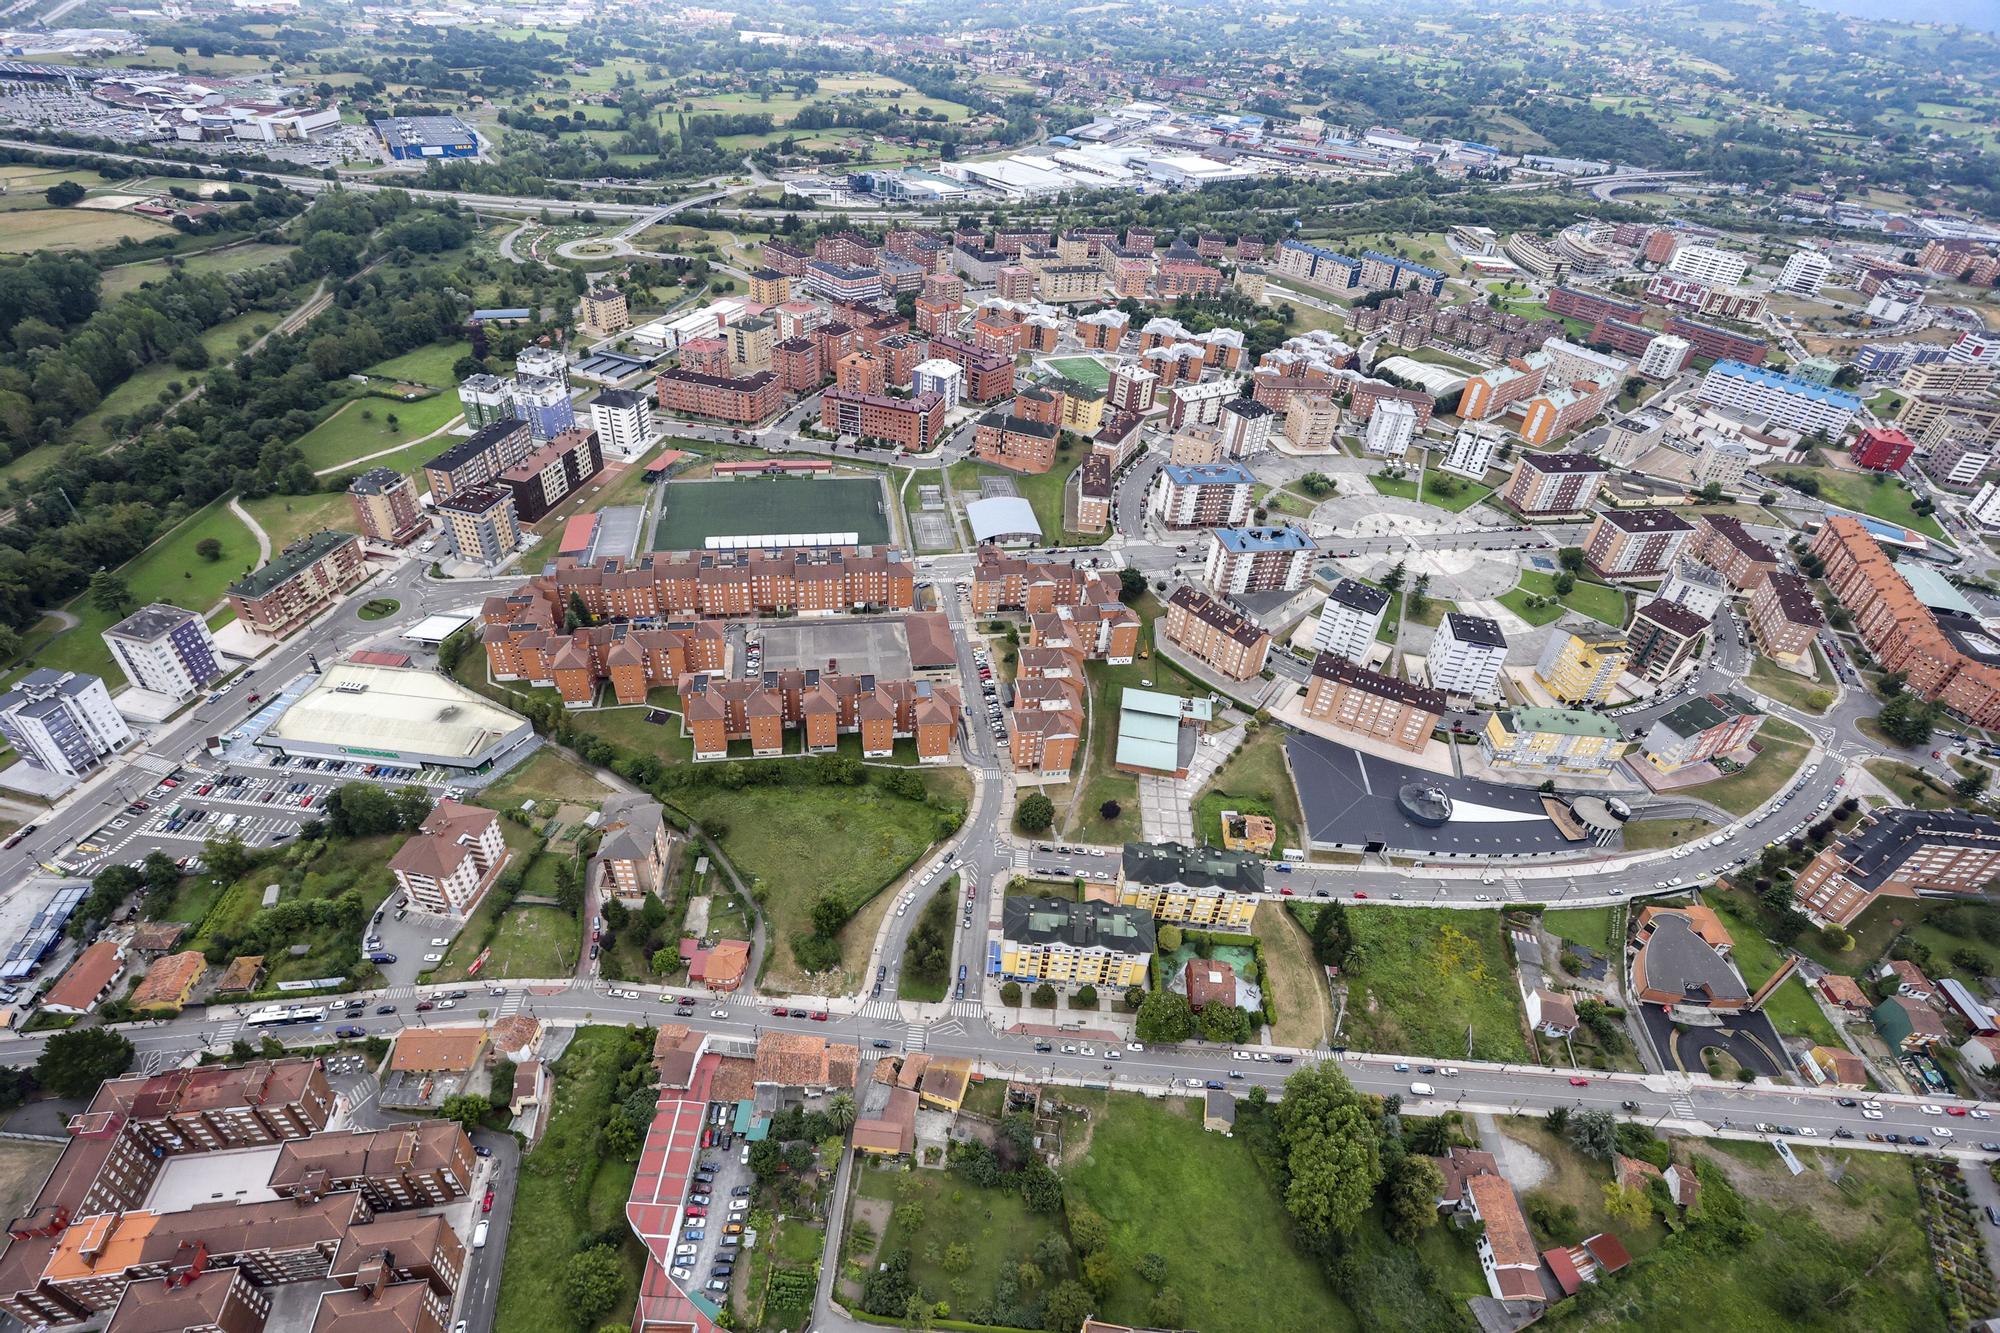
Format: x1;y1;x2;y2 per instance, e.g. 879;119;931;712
1792;809;2000;925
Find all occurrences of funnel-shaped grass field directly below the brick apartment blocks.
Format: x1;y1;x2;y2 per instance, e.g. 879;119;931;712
676;771;970;995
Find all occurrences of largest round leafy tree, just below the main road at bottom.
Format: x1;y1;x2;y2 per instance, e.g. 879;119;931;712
1276;1065;1382;1241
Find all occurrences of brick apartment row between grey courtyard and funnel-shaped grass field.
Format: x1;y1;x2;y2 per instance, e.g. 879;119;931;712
680;667;960;765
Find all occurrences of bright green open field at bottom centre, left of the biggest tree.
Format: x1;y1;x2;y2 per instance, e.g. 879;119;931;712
1068;1097;1356;1333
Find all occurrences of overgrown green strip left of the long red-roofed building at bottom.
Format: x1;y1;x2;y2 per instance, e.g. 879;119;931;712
494;1027;646;1333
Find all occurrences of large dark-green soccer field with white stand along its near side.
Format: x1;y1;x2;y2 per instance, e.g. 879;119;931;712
652;476;890;550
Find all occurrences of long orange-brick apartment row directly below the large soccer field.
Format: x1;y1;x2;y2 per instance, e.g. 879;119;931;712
546;546;914;620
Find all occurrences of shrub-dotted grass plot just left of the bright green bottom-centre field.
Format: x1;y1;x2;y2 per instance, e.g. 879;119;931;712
848;1159;1058;1307
